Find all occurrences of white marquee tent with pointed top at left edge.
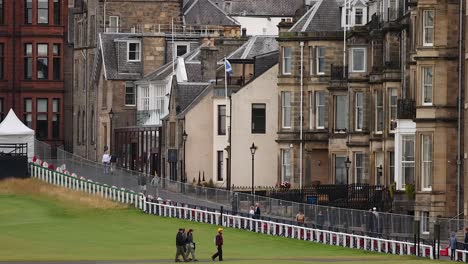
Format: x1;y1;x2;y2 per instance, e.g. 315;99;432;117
0;109;34;160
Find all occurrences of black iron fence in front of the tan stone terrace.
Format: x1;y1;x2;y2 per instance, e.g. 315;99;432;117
241;184;392;211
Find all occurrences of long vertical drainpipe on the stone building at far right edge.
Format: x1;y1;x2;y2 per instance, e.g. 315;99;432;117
457;0;463;218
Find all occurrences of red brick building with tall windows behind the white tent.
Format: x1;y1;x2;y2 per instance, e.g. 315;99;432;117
0;0;68;146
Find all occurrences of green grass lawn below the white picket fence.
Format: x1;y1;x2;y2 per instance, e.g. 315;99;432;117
0;178;450;264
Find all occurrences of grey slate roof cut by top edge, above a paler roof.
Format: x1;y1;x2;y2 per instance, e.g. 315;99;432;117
215;0;304;17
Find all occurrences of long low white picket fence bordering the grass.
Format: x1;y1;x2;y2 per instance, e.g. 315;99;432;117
31;163;436;260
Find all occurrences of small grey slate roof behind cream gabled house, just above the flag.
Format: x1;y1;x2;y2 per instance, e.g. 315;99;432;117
228;36;278;60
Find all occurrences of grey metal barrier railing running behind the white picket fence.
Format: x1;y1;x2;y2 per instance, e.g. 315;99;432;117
35;146;468;240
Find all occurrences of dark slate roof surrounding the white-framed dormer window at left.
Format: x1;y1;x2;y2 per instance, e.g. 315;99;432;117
99;33;141;80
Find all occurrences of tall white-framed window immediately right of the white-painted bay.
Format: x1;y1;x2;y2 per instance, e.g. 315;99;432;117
421;134;434;191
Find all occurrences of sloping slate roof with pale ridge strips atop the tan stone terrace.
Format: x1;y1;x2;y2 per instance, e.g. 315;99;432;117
289;0;343;32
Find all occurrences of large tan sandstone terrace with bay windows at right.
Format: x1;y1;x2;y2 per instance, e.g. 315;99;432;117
278;0;461;223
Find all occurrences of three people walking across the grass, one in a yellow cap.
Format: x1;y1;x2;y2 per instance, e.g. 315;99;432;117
175;228;223;262
